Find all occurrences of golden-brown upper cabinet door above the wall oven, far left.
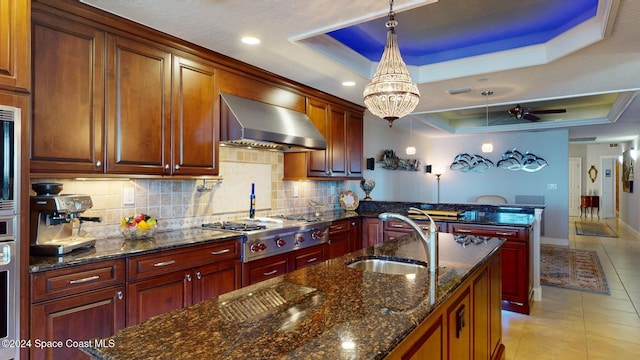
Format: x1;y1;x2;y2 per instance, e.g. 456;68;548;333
0;0;31;91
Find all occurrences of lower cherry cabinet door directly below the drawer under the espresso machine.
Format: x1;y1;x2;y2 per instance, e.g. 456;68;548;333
29;285;125;360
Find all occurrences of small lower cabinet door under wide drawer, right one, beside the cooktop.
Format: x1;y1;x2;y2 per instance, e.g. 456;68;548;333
193;259;242;303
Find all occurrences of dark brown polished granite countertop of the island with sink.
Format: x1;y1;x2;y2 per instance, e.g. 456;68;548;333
83;233;504;359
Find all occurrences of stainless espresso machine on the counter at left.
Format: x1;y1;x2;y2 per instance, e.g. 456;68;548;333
30;187;100;256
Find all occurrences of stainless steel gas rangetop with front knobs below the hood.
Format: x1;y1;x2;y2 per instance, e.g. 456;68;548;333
202;218;330;263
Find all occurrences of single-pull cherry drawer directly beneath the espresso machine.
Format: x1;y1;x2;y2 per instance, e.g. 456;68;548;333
31;259;125;302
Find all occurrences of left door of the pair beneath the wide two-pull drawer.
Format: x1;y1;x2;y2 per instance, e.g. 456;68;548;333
127;270;193;326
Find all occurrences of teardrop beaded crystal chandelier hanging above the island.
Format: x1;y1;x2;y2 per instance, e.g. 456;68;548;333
363;0;420;127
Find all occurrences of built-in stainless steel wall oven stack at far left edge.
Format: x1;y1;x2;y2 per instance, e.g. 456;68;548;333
0;105;22;359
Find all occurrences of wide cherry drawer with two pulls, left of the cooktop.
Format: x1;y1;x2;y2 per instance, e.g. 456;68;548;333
127;240;240;280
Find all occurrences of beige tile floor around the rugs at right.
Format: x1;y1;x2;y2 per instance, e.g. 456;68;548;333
502;217;640;360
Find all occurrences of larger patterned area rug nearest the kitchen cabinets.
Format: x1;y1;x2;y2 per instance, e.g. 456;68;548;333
540;245;611;295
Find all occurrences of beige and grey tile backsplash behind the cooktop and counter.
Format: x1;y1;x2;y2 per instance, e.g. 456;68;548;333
32;147;344;238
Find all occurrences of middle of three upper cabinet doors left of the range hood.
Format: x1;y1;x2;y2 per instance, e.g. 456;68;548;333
106;35;172;175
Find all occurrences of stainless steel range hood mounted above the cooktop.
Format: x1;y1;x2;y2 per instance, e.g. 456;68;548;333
220;93;327;151
